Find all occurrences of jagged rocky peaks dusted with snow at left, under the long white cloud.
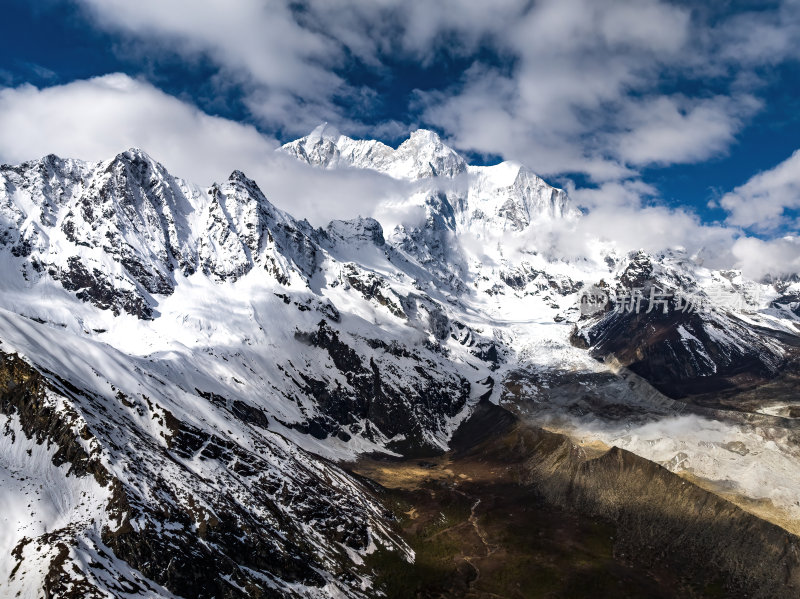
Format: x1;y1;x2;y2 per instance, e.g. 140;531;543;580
0;155;328;319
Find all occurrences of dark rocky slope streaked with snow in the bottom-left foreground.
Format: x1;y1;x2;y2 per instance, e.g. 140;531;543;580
0;354;406;598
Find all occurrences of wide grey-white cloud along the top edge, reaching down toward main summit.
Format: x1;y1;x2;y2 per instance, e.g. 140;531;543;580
67;0;526;135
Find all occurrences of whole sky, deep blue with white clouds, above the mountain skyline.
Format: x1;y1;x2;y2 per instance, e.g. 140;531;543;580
0;0;800;268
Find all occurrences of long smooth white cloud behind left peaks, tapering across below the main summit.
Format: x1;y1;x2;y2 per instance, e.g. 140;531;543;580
0;74;407;225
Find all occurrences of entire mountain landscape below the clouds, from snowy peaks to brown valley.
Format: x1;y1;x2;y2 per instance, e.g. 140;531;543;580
0;126;800;599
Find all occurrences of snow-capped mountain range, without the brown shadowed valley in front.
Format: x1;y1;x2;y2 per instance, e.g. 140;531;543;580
0;126;800;597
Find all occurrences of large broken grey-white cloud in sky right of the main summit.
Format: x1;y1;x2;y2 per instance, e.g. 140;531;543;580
419;0;780;182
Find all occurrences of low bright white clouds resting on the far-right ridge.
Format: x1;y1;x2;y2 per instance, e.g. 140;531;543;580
556;178;800;280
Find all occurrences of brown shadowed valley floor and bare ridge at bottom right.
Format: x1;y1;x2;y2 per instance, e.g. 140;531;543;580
353;404;800;598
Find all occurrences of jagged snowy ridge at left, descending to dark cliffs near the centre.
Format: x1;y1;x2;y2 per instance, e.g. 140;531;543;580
0;145;500;456
